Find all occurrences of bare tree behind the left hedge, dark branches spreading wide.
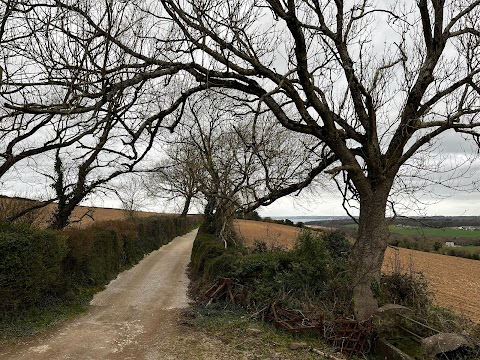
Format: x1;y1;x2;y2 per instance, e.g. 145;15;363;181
0;0;206;228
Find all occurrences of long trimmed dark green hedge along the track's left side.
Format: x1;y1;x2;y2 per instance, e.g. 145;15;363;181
0;216;200;313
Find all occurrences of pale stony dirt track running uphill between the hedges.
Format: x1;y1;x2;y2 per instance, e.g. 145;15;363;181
0;231;244;360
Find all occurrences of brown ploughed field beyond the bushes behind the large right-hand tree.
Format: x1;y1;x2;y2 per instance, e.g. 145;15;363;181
235;220;480;323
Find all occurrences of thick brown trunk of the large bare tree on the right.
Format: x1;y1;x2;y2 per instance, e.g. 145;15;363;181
350;191;389;321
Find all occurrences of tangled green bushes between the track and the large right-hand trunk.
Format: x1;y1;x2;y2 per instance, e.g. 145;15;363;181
191;231;350;316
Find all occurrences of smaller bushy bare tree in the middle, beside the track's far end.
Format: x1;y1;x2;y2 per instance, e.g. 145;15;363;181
153;92;330;245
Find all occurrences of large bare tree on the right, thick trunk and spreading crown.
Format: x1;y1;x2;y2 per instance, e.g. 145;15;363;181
157;0;480;320
